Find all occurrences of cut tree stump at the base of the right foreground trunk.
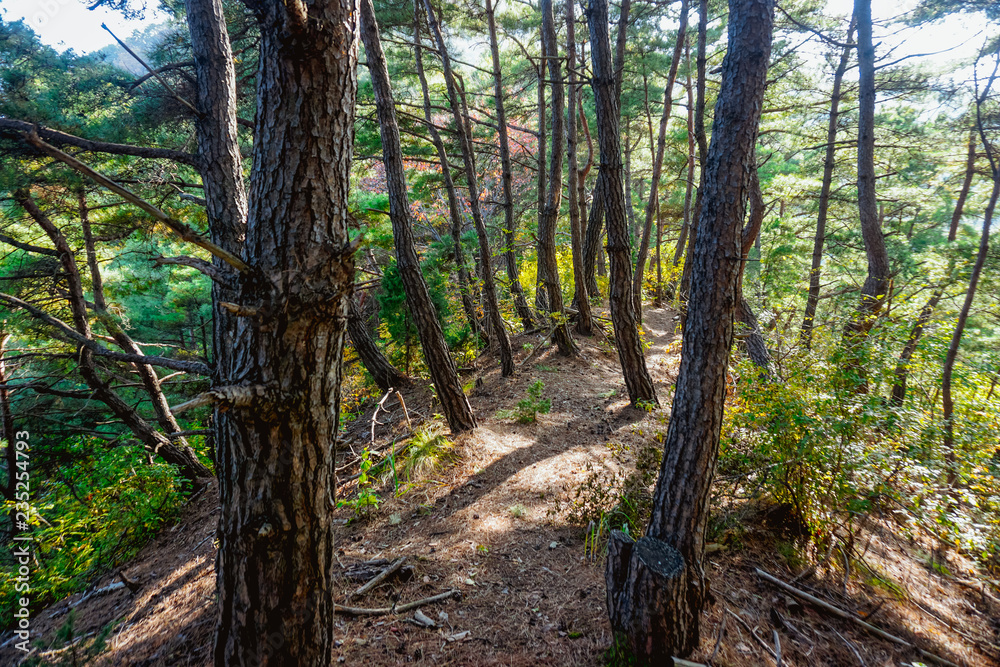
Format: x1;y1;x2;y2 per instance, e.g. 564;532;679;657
605;530;698;665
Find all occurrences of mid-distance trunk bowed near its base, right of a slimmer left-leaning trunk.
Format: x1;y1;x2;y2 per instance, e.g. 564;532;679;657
538;0;578;355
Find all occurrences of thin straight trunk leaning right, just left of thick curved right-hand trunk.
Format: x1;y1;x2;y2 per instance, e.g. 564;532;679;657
799;18;855;350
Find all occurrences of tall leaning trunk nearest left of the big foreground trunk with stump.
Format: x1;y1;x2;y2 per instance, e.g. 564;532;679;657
587;0;657;405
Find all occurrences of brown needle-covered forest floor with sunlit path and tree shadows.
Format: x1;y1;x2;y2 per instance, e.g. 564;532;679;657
7;306;1000;667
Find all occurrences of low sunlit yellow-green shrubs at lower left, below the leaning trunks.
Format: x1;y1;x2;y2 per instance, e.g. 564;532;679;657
0;438;183;619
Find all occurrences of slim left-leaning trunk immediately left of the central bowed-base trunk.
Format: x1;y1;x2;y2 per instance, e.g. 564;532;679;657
486;0;536;331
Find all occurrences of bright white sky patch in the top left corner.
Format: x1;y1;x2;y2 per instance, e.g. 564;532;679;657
0;0;162;54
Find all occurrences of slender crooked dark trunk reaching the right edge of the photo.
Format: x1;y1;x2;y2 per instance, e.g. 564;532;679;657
941;150;1000;486
